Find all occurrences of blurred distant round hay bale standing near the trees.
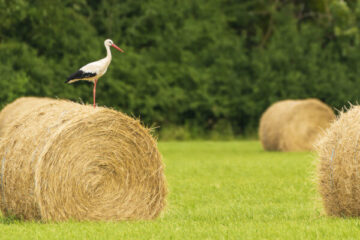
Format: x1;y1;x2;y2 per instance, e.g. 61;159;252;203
259;99;335;151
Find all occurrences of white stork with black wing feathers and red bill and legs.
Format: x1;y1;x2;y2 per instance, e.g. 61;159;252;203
65;39;124;108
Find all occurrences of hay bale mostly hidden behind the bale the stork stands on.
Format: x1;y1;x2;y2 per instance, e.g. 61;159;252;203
0;97;51;137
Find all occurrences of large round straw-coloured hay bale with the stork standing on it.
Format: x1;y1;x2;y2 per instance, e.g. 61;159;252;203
0;97;167;221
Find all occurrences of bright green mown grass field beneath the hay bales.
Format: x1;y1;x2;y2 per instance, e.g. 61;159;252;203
0;141;360;239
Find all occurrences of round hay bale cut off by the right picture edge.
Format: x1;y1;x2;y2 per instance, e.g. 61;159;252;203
316;106;360;217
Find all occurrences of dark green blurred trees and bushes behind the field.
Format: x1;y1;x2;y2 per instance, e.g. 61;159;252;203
0;0;360;139
